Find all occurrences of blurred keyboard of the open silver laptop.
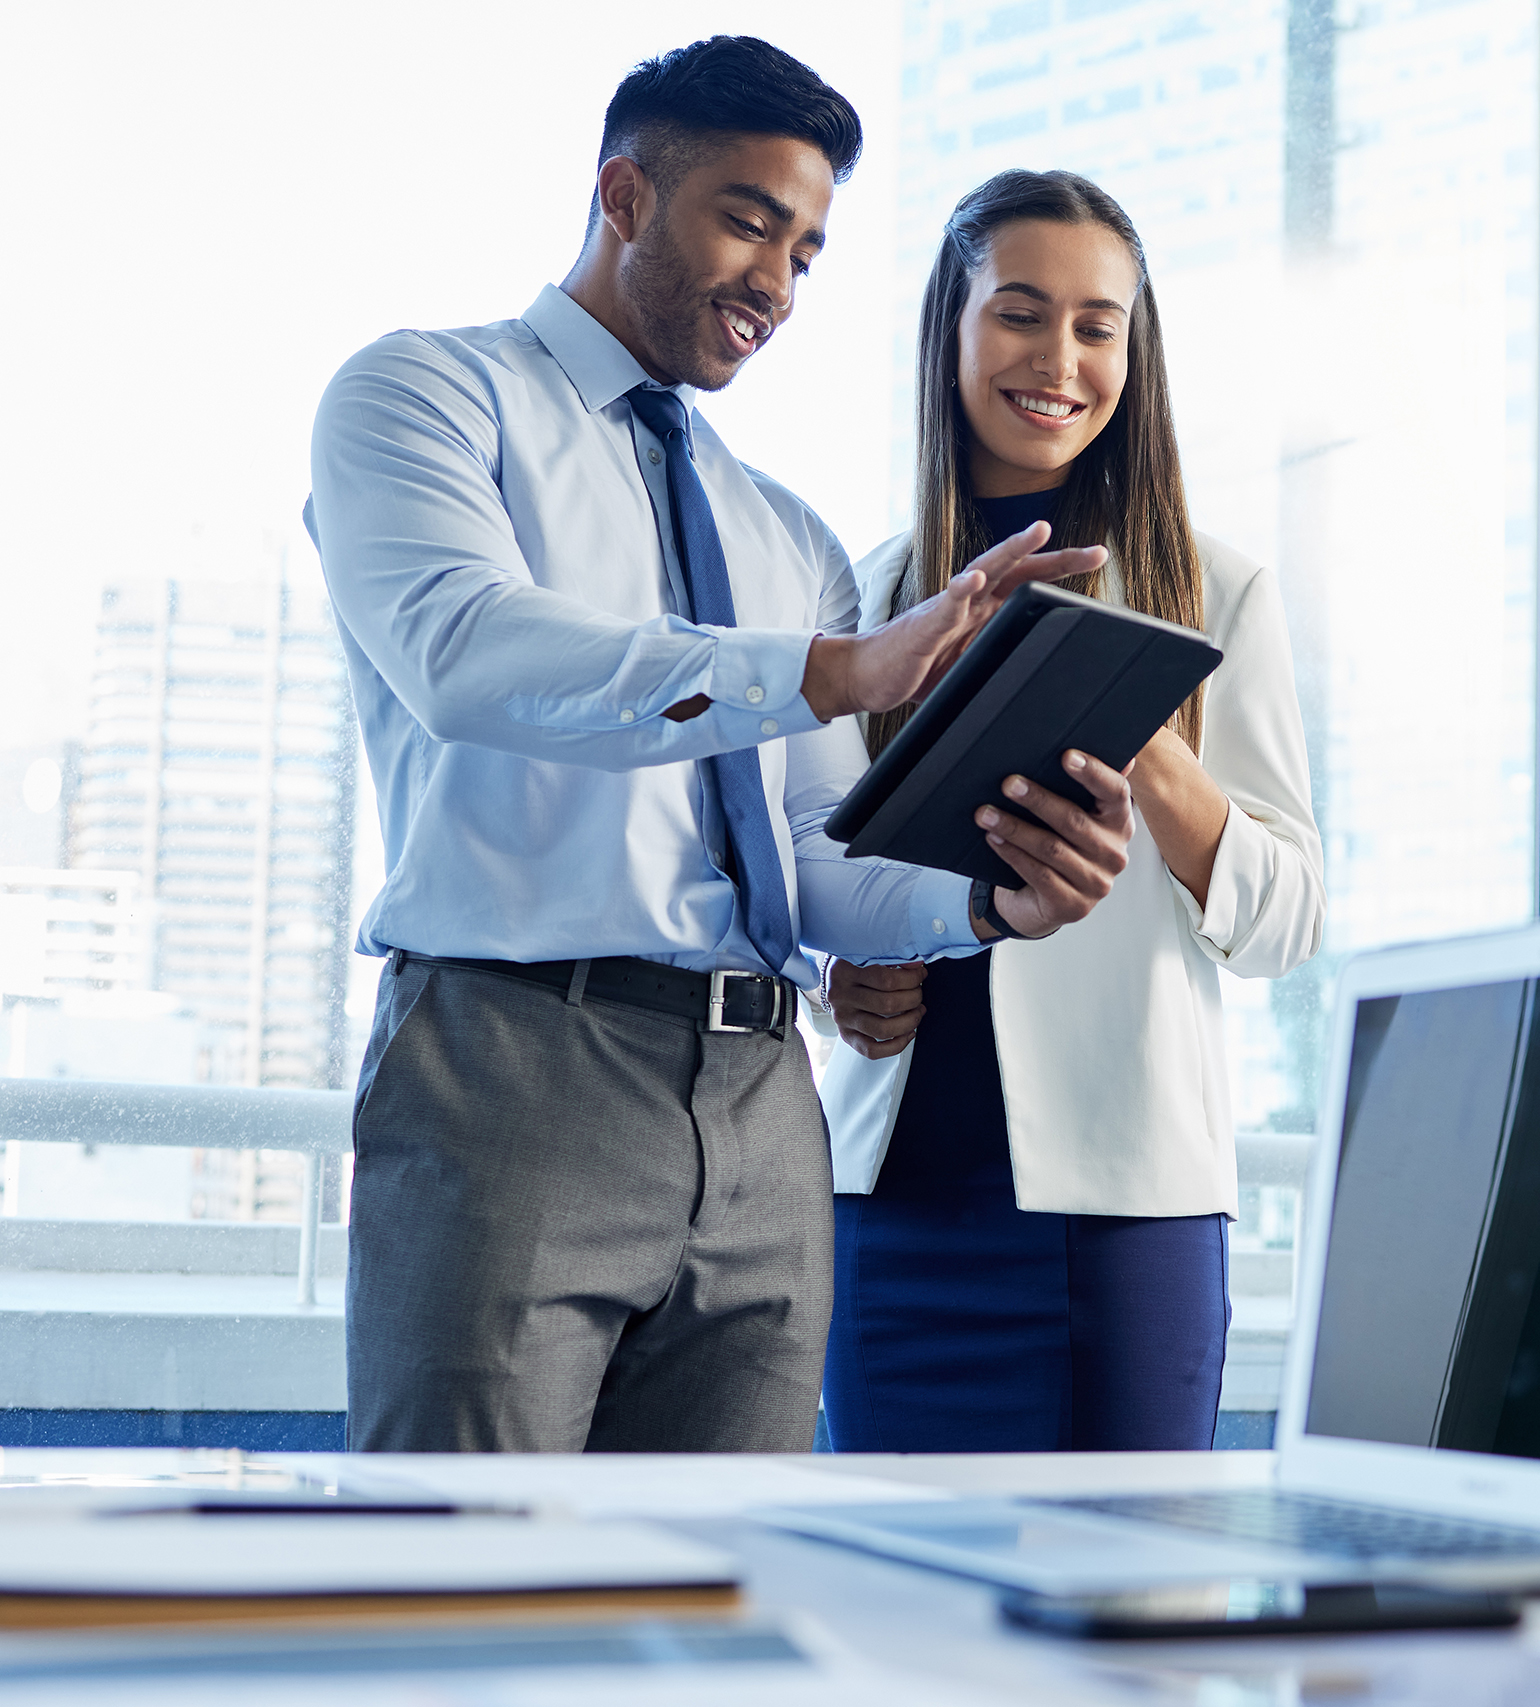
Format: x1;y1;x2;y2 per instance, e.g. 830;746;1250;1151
1053;1489;1540;1558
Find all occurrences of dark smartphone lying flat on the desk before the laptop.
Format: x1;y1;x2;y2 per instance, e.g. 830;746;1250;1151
1000;1577;1521;1640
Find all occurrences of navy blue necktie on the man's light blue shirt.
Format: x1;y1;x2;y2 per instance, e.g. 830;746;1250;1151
627;386;792;973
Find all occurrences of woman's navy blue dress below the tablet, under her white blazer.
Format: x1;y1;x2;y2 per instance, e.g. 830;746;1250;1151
823;954;1229;1453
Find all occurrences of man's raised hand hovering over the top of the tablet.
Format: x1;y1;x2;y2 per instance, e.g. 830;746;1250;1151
802;522;1106;724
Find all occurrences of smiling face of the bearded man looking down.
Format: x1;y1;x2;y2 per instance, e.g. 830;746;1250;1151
620;137;835;391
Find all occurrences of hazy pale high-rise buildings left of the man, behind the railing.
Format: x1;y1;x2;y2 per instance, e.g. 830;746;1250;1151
0;580;357;1221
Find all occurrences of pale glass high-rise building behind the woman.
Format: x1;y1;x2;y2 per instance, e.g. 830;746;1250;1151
893;0;1537;1132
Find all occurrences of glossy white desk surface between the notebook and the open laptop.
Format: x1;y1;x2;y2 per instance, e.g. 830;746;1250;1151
0;1449;1540;1707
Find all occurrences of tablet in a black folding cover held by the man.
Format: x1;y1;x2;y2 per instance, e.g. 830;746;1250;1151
825;582;1224;889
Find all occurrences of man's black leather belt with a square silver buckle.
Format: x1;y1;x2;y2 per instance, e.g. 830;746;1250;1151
391;949;796;1033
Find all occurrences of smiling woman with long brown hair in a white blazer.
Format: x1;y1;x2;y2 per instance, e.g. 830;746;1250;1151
823;171;1325;1451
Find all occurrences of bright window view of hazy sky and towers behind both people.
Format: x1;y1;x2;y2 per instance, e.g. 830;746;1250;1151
0;0;1537;1408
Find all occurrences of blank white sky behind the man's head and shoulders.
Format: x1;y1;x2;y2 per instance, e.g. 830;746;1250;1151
0;0;898;748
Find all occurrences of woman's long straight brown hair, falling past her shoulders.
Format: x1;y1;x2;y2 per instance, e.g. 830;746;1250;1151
866;171;1204;758
